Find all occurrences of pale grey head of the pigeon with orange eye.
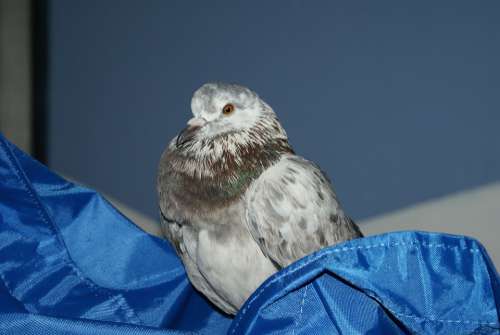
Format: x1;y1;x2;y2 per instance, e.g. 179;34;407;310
175;83;287;149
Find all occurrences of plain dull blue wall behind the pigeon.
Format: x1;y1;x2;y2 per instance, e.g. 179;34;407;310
48;0;500;219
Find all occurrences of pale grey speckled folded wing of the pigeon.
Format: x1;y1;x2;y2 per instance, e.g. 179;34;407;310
245;155;362;267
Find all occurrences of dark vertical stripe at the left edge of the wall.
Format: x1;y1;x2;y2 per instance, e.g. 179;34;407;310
31;0;49;164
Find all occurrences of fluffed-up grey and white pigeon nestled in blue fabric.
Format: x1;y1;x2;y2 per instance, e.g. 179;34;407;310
157;82;363;315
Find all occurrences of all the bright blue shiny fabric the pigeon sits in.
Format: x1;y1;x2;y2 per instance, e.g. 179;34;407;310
0;135;500;334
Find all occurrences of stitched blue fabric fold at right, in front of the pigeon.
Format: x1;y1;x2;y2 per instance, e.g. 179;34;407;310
229;232;500;334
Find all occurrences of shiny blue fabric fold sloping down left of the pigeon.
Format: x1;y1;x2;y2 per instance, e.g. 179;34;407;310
0;133;231;332
